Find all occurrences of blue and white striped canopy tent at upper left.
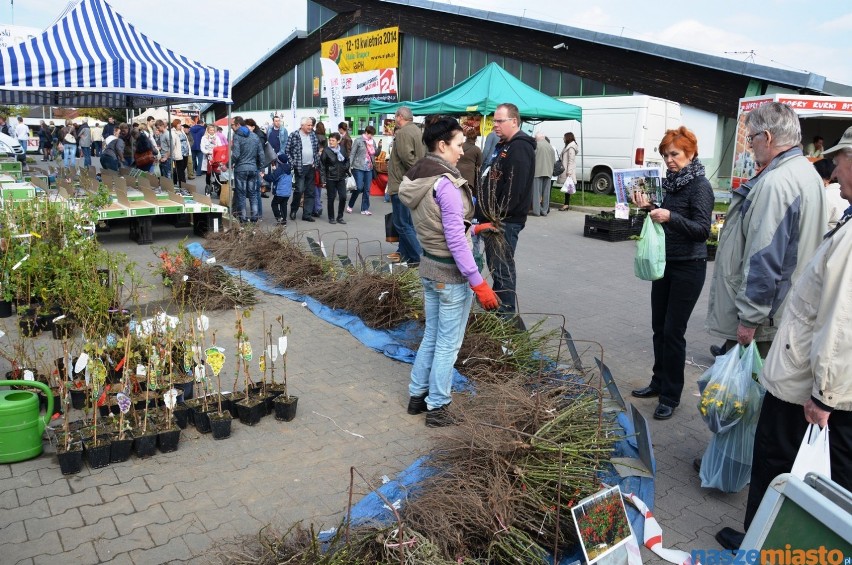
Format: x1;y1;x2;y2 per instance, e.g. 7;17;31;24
0;0;231;108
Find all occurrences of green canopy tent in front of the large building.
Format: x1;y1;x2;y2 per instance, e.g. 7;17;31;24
370;63;583;122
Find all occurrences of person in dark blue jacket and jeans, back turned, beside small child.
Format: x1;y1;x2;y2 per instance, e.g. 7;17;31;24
231;116;263;222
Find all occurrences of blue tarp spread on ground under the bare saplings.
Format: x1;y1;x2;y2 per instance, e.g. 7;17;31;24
187;243;654;552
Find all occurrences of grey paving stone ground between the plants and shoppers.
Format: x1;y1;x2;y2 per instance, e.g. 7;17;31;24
0;178;745;565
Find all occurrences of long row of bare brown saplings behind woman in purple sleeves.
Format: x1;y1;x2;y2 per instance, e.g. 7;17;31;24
205;229;423;329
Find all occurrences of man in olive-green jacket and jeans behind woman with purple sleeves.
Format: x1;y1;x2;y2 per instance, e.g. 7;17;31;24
388;106;426;264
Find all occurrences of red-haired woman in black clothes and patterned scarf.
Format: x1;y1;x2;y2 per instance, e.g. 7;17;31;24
632;126;714;420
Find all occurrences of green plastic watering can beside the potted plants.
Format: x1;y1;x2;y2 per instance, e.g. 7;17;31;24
0;380;53;463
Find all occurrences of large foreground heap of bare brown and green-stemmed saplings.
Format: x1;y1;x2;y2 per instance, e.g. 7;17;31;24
403;374;615;563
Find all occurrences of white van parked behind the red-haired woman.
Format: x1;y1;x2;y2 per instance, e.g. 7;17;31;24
535;95;681;194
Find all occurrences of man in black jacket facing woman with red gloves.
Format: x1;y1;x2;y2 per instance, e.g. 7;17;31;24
476;99;535;328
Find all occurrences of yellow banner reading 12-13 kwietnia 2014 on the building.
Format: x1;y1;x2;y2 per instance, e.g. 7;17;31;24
320;27;399;75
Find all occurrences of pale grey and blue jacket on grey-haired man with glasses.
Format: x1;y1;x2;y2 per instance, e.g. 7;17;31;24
706;147;828;341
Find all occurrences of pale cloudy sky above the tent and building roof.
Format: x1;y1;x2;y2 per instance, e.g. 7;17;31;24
0;0;852;85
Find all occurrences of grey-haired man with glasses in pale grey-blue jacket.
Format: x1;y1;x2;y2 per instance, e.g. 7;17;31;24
706;102;828;549
